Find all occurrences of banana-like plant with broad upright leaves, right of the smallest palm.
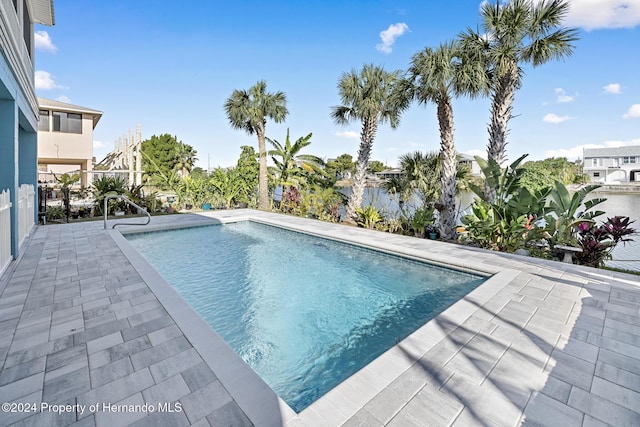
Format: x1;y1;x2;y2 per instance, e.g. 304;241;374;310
266;128;324;194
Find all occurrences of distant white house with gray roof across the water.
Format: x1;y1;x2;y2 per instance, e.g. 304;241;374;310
583;145;640;183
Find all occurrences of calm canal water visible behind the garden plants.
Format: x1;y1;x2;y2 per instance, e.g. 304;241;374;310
341;187;640;271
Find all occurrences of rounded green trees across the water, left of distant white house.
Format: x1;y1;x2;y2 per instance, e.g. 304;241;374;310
520;157;586;192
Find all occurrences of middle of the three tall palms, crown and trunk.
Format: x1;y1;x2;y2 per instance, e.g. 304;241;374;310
409;41;486;239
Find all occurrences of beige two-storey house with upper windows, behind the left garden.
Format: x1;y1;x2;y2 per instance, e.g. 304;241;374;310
38;98;102;187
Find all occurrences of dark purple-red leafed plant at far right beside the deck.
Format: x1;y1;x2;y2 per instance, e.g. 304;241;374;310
574;216;636;267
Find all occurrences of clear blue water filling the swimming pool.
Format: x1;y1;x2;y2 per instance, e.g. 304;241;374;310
127;222;485;412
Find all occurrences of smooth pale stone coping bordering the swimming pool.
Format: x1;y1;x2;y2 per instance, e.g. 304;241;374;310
108;211;520;425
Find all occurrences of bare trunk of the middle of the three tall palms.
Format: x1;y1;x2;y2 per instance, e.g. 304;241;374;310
438;96;458;240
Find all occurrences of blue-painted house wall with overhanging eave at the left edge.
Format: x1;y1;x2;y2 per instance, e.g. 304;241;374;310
0;0;54;273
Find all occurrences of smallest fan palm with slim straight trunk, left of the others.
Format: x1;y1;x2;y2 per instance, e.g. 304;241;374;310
224;80;289;210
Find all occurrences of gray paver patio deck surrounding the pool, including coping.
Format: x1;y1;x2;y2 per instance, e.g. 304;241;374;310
0;210;640;427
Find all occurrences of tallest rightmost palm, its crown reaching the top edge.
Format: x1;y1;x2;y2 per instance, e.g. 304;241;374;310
460;0;578;164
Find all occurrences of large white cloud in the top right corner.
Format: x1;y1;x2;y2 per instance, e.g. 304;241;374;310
564;0;640;31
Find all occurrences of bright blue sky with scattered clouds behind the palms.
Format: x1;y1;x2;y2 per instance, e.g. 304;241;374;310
36;0;640;168
